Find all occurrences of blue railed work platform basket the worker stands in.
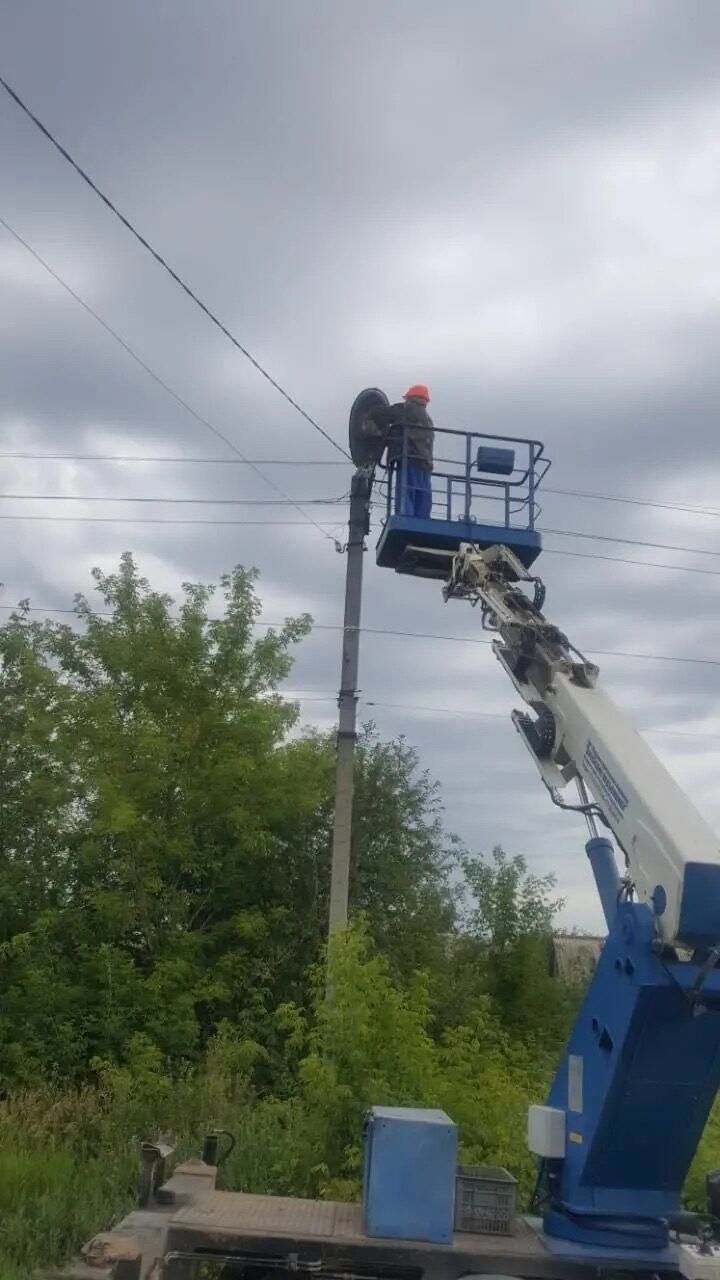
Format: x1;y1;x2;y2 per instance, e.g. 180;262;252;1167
377;424;550;579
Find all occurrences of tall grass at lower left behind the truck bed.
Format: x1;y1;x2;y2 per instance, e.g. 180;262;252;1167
0;1066;297;1280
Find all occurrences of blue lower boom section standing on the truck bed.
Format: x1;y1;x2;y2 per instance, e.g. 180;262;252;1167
544;902;720;1249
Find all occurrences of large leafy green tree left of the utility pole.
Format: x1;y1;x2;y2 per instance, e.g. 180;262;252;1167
0;556;323;1074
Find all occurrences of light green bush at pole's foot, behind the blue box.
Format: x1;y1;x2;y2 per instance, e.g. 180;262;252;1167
278;927;550;1199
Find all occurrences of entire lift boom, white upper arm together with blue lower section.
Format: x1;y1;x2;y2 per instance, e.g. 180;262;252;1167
443;543;720;1249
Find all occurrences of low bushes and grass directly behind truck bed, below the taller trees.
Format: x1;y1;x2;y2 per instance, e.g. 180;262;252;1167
0;927;544;1276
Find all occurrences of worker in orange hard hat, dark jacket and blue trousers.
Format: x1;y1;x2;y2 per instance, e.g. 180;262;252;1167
364;383;433;520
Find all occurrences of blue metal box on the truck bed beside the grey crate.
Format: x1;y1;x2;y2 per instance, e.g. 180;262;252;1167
363;1107;457;1244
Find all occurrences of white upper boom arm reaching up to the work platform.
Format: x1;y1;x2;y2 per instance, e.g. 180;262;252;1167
445;545;720;946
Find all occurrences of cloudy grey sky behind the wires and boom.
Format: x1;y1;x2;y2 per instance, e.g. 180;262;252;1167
0;0;720;928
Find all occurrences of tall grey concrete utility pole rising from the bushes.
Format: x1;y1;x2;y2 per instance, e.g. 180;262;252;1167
328;467;372;936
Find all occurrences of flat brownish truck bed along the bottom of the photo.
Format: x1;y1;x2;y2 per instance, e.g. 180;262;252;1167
60;1161;676;1280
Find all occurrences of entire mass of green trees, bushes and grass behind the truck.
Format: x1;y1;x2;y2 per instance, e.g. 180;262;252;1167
16;556;720;1280
